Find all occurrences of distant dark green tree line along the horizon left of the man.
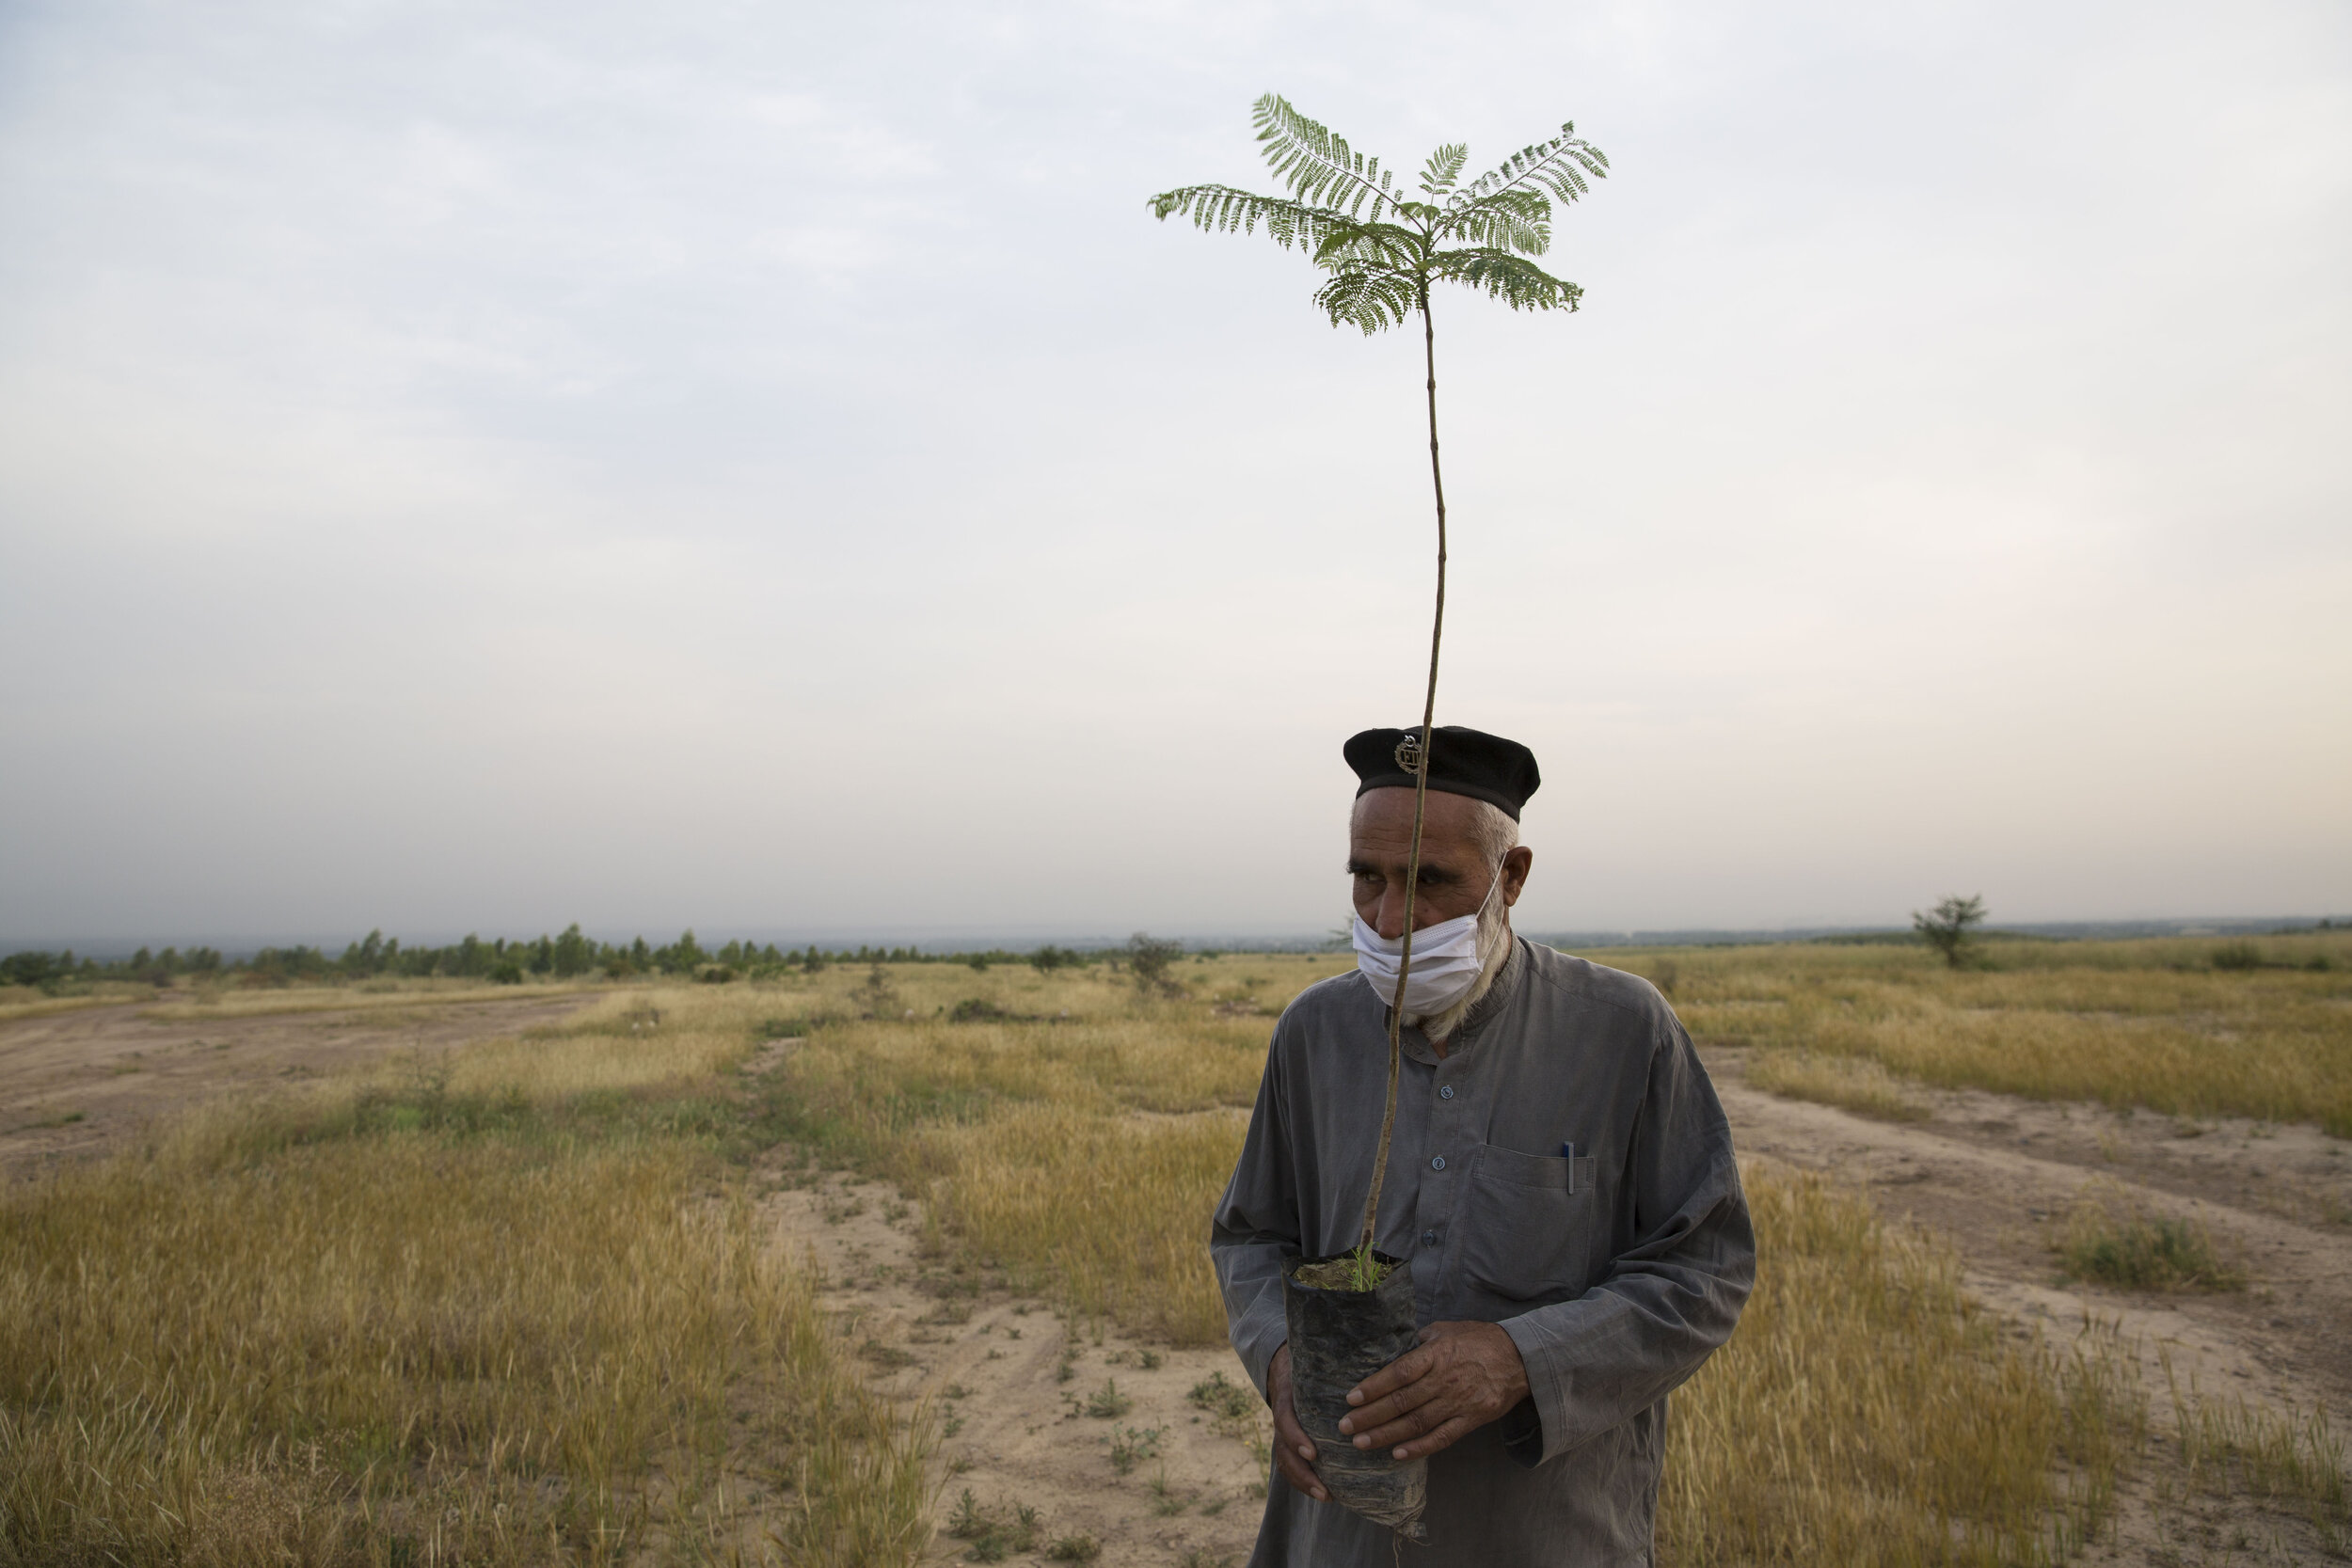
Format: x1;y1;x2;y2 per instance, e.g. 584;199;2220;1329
0;924;1148;992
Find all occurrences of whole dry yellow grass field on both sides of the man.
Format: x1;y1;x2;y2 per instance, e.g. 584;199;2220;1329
0;938;2352;1566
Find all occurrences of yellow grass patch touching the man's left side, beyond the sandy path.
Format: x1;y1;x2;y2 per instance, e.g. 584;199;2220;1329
734;957;1343;1345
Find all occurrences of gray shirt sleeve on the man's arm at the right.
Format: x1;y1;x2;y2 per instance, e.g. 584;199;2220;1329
1503;1022;1755;1465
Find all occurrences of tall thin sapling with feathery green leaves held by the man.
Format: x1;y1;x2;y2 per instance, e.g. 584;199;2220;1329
1151;94;1609;1267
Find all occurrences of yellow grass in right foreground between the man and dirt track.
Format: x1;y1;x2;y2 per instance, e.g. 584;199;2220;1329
1659;1166;2148;1568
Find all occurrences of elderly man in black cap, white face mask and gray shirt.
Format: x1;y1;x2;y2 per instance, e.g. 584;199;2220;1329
1209;726;1755;1568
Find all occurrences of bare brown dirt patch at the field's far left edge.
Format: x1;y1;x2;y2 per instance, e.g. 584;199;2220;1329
0;994;591;1180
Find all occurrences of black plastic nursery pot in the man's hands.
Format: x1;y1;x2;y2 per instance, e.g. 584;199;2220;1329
1282;1253;1430;1540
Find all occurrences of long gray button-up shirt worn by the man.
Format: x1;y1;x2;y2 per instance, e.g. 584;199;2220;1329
1209;941;1755;1568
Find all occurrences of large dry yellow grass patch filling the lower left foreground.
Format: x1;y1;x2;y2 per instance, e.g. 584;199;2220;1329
0;987;930;1566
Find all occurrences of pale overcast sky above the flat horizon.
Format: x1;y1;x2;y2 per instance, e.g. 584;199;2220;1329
0;0;2352;942
